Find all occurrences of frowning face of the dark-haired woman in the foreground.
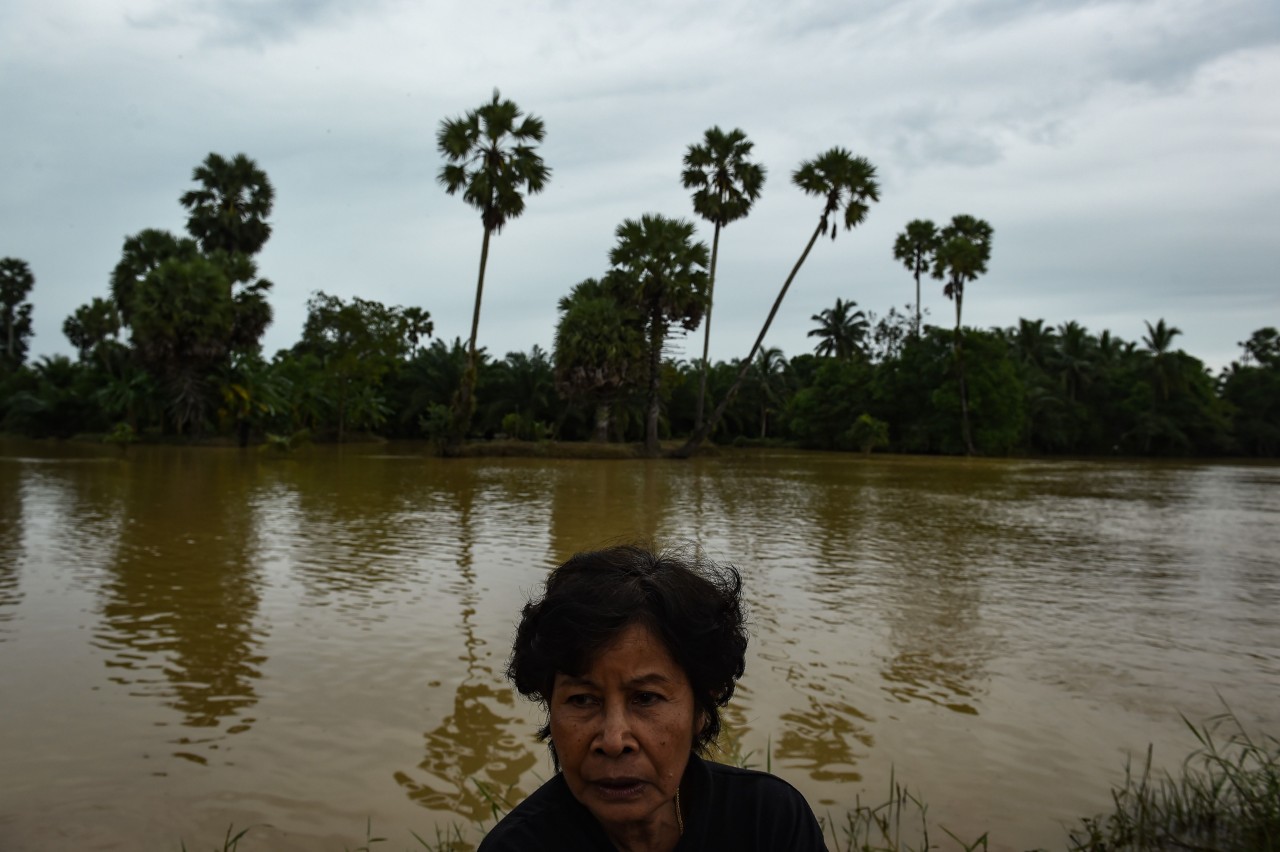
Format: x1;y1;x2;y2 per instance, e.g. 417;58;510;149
550;616;700;835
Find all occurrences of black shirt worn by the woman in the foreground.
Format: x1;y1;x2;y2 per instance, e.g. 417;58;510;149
477;755;827;852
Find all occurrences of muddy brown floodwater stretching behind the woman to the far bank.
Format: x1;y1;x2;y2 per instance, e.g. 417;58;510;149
0;443;1280;852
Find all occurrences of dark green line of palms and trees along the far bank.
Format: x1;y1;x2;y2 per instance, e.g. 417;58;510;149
0;91;1280;457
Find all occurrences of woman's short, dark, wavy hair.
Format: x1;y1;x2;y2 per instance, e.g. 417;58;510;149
507;545;746;757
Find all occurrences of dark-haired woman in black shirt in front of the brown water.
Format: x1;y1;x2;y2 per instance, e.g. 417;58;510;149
480;546;826;852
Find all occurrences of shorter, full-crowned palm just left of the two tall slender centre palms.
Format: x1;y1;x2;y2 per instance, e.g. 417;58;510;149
607;214;708;457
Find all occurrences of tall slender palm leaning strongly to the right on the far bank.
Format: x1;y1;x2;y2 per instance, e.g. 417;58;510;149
676;147;879;458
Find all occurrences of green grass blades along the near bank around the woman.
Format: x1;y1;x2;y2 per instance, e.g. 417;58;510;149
182;709;1280;852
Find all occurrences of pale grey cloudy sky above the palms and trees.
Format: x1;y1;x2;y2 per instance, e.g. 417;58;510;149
0;0;1280;367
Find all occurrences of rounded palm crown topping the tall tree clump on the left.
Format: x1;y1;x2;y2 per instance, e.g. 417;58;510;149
179;154;275;255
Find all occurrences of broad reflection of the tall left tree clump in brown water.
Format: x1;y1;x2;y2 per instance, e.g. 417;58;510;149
97;452;265;741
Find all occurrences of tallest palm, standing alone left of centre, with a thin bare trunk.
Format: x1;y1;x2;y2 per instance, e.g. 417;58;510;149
435;88;552;441
